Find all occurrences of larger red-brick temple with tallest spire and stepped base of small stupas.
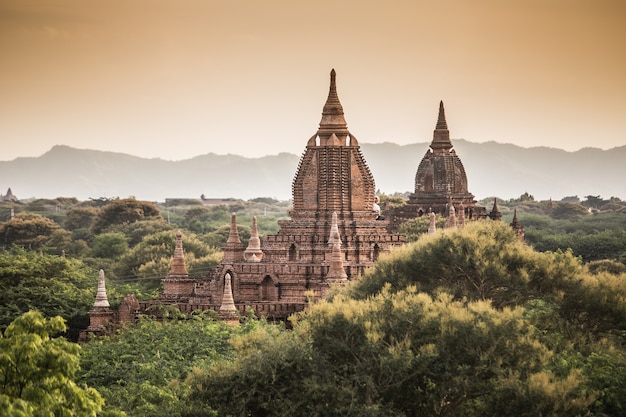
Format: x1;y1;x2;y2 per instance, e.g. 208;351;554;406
138;70;403;319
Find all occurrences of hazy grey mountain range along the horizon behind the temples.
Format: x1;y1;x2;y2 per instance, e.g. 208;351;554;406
0;139;626;202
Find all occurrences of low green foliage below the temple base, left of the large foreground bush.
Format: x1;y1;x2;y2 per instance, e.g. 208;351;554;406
78;316;241;417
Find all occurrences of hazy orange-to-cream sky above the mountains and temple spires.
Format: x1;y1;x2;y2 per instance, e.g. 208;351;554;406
0;0;626;161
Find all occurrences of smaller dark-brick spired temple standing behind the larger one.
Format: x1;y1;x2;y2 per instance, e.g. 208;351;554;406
390;101;487;227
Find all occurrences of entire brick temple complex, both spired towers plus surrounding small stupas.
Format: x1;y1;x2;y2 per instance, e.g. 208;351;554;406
81;70;524;334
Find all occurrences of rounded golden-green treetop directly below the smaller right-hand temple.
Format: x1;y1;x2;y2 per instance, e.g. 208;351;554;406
351;221;580;307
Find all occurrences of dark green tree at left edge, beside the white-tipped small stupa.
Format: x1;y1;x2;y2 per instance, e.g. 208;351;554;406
0;248;98;339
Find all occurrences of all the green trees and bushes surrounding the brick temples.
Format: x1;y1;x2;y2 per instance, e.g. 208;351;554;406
0;195;626;417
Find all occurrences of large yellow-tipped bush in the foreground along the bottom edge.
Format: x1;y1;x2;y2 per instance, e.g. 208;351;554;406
189;287;593;416
